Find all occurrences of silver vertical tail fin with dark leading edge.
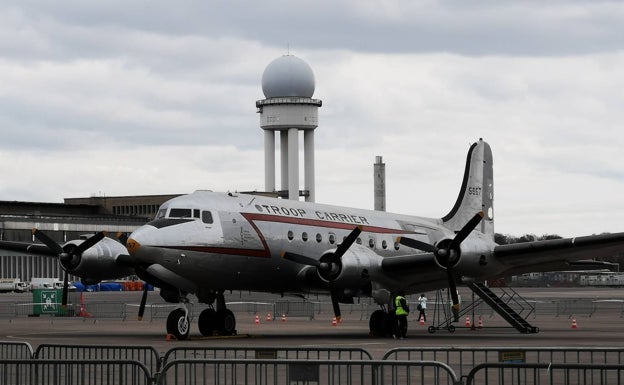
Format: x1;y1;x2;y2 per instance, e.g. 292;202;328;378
442;139;494;239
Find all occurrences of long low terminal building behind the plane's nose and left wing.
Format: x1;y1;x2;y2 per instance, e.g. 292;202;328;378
0;194;181;282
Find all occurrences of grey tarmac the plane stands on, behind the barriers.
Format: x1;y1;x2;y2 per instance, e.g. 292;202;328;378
0;288;624;359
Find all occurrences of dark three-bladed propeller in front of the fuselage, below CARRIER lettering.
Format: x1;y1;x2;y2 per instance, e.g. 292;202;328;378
282;226;362;322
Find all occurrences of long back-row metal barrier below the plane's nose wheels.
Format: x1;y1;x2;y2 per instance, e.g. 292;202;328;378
163;347;373;364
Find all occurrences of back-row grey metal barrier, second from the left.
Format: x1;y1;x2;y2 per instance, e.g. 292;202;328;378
33;344;162;372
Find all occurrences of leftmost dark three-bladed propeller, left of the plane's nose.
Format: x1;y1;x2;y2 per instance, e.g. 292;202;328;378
32;229;107;307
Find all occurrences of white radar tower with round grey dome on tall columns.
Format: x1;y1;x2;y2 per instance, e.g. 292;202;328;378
256;55;322;202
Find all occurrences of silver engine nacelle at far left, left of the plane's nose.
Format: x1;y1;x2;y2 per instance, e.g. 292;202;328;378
63;237;134;281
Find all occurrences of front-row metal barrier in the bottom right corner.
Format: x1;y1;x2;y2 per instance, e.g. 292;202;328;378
465;363;624;385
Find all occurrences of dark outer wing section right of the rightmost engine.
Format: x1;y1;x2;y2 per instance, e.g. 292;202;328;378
493;233;624;275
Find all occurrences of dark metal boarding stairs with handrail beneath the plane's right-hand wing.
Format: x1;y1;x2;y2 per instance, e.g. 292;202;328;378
468;282;539;334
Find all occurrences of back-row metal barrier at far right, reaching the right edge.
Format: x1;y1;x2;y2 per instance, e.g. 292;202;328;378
383;347;624;377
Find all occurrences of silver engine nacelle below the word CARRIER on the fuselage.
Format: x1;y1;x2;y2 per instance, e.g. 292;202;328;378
319;245;381;289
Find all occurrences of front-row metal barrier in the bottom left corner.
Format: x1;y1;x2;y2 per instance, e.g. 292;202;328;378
0;359;152;385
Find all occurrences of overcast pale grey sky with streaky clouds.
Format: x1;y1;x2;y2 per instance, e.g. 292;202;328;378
0;0;624;236
